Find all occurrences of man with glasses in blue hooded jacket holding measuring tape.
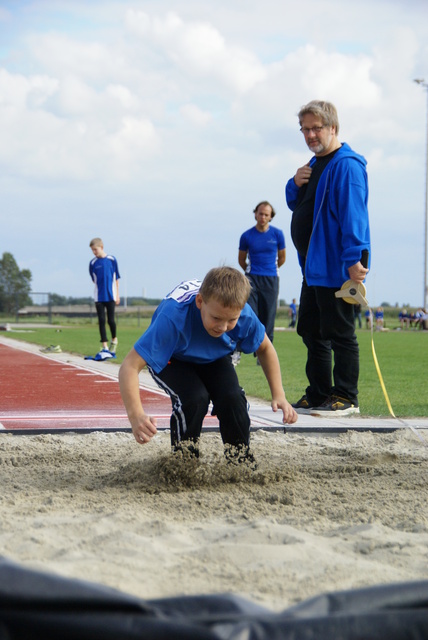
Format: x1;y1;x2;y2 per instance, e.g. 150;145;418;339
285;100;370;417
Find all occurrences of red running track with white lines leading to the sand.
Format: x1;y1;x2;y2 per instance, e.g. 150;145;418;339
0;344;218;433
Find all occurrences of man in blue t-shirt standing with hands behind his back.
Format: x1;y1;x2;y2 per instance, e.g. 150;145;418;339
238;200;285;356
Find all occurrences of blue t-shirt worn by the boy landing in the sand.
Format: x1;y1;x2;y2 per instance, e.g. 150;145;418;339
134;280;265;373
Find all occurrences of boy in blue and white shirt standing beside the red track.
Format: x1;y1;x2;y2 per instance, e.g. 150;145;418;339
89;238;120;354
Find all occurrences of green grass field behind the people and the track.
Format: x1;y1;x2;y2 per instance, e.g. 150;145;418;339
7;318;428;418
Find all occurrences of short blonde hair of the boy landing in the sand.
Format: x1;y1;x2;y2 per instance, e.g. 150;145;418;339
199;267;251;309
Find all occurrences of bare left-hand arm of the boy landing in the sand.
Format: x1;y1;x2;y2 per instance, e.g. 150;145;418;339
119;349;157;444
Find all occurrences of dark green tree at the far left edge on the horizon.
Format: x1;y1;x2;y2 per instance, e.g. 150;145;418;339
0;252;32;313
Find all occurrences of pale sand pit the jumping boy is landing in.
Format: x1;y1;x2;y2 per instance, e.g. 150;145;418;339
0;429;428;611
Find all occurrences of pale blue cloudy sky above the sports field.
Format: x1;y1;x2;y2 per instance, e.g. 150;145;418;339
0;0;428;306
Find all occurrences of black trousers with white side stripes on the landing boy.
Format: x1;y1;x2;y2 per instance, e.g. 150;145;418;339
149;356;250;446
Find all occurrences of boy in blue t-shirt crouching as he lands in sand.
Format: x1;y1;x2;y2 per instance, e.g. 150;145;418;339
119;267;297;462
